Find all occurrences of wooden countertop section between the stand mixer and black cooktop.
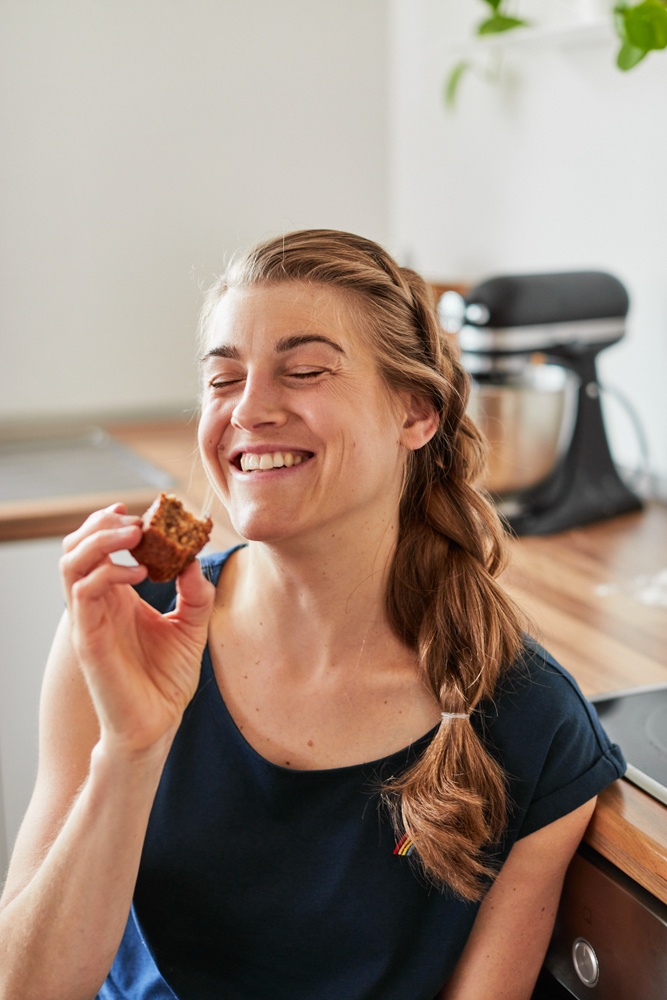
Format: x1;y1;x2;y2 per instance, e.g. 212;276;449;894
502;504;667;695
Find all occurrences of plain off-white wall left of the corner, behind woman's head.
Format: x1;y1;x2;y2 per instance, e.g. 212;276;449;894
0;0;387;419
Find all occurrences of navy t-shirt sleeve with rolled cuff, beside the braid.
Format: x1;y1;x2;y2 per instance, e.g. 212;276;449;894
486;640;626;840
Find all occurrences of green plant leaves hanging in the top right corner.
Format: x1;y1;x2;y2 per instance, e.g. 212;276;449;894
444;0;667;108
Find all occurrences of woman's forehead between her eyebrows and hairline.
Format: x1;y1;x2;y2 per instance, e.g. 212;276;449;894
206;282;362;352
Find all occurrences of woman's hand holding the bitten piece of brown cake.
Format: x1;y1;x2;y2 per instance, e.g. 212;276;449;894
60;504;215;754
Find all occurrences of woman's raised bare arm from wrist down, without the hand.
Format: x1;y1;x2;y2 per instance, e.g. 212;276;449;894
0;624;175;1000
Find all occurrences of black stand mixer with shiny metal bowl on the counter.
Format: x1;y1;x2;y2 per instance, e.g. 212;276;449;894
439;271;641;535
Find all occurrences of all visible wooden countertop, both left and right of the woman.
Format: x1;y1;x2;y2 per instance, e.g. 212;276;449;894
0;421;667;903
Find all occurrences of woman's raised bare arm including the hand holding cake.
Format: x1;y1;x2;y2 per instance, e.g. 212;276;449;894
0;509;214;1000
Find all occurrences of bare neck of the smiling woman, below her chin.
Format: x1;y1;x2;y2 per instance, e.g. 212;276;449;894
219;510;408;673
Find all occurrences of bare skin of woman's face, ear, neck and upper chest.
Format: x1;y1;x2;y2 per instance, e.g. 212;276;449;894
200;284;439;768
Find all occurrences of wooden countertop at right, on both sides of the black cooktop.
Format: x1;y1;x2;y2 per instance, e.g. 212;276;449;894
503;504;667;903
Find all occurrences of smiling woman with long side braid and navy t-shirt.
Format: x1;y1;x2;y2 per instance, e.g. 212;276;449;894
0;231;623;1000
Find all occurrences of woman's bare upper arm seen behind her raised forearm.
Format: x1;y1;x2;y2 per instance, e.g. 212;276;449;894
0;613;99;908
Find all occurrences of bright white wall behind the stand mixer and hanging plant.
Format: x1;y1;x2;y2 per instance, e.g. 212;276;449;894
390;0;667;477
